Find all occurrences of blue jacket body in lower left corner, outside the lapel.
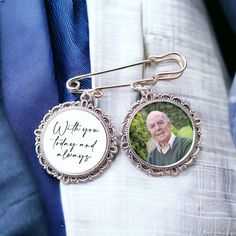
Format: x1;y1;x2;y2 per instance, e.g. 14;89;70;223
0;96;49;236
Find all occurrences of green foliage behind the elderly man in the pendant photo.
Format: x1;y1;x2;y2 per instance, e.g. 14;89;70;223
129;102;193;161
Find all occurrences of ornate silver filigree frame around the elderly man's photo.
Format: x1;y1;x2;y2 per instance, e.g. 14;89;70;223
121;92;201;176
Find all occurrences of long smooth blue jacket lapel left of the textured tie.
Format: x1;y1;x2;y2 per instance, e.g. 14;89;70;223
1;0;65;236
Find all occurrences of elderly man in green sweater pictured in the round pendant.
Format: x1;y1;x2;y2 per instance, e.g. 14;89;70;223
146;111;192;166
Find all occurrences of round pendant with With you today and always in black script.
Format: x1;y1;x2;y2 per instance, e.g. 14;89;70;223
34;95;118;183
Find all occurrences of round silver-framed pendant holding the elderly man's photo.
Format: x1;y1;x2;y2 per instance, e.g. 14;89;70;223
121;91;201;176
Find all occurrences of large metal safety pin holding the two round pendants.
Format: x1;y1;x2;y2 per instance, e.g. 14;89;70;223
66;52;187;93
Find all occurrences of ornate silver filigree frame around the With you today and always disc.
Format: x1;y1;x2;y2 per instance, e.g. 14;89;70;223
34;99;118;183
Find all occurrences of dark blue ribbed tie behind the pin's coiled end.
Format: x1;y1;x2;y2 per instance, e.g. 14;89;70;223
47;0;91;102
